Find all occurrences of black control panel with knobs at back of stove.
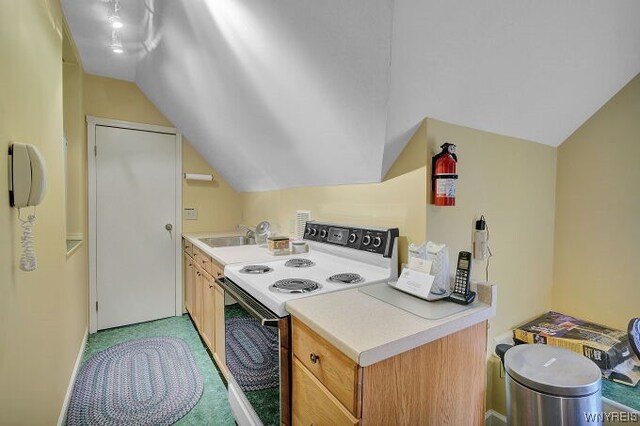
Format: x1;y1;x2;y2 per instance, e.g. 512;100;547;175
304;221;399;257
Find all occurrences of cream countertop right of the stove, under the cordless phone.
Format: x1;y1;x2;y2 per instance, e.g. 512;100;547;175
287;285;497;367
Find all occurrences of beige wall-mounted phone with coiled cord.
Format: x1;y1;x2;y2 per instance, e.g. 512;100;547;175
9;143;47;271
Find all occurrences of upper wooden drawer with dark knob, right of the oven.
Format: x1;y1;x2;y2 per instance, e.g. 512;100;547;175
292;317;360;417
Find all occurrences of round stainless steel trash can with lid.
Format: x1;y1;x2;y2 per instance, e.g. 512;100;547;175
504;345;602;426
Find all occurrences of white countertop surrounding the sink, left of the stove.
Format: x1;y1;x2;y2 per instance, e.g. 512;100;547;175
182;231;282;266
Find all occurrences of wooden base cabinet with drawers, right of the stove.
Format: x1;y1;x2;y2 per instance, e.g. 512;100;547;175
292;317;487;426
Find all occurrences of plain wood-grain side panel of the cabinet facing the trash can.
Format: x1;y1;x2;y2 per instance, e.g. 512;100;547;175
361;321;486;426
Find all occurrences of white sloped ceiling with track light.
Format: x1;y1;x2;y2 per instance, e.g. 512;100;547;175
62;0;640;191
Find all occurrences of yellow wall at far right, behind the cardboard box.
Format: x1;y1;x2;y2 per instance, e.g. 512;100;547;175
553;75;640;329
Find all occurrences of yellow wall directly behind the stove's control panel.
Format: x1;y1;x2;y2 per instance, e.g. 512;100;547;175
242;121;426;261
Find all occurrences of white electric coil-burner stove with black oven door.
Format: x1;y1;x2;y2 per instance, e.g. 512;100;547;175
217;222;398;426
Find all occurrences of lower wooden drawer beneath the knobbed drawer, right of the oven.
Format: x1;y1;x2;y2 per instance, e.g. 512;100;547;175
292;357;359;426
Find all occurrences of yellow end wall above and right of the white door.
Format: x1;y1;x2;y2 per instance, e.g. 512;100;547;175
84;74;242;232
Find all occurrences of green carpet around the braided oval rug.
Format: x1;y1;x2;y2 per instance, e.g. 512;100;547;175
82;315;235;426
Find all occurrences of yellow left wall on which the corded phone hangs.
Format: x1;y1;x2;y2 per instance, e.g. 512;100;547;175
0;0;87;425
